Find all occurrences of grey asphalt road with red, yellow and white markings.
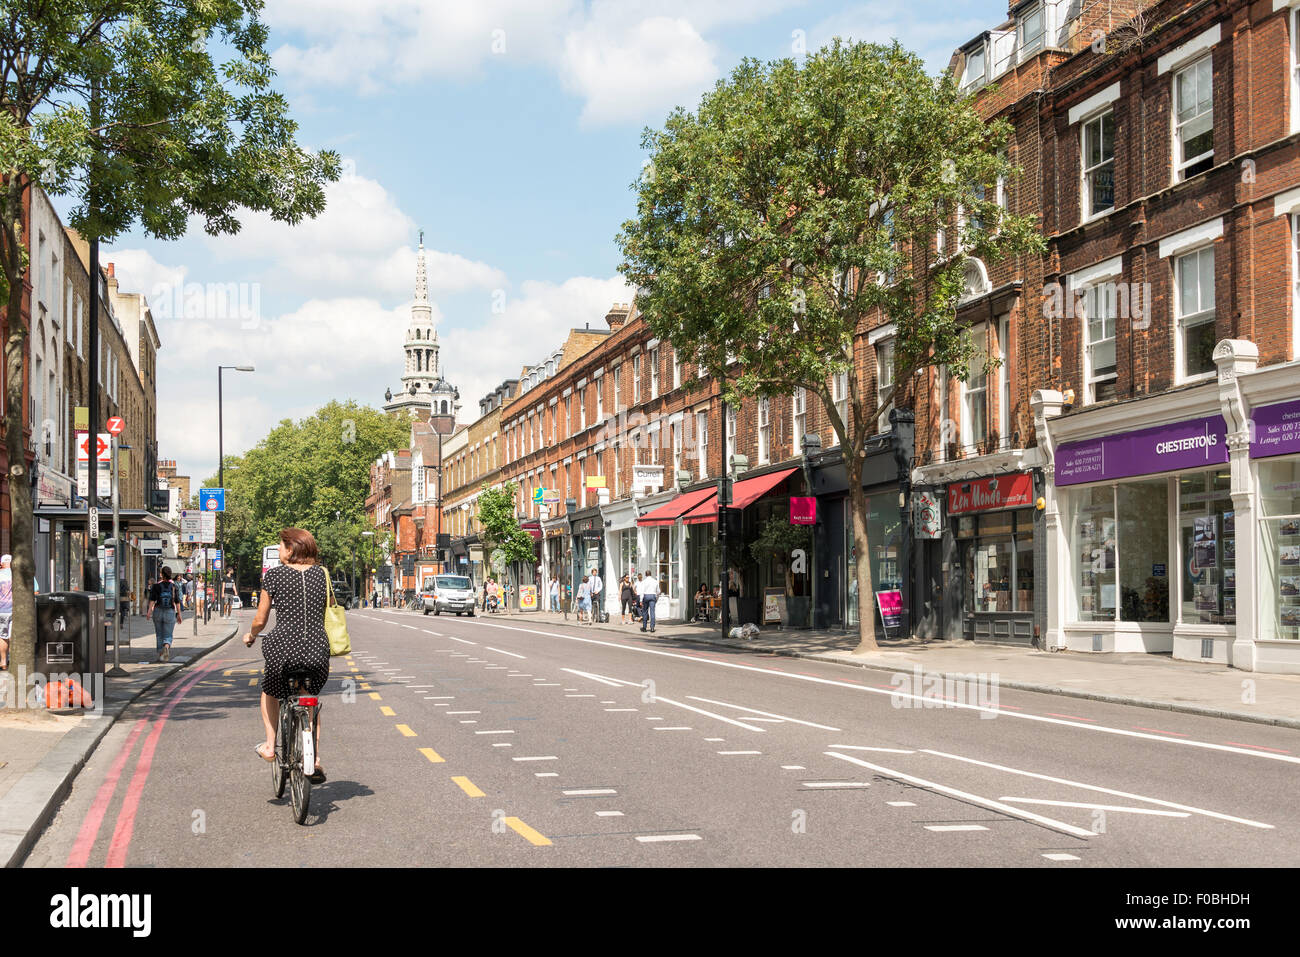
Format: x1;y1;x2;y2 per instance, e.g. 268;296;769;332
26;610;1300;869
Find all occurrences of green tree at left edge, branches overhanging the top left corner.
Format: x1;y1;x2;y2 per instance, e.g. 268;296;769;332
0;0;339;696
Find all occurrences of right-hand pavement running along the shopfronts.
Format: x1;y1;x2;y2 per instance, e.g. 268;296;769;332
478;611;1300;728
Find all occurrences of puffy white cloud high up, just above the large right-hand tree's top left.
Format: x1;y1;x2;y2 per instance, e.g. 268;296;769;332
560;17;719;126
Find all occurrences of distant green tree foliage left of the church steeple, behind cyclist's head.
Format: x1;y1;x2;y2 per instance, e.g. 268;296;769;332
204;402;411;581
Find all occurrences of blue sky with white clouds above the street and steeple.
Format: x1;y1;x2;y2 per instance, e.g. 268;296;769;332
89;0;1008;480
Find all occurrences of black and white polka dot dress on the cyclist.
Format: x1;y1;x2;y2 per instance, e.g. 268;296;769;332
261;564;329;701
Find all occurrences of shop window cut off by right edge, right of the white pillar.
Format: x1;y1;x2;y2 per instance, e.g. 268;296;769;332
1258;456;1300;641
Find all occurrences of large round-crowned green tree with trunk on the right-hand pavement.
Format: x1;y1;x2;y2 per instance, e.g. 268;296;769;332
619;40;1041;650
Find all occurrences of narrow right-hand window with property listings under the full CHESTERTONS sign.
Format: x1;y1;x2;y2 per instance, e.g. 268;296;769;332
1178;471;1236;624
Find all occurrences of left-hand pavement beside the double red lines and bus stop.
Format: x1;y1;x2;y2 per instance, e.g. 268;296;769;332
0;612;238;867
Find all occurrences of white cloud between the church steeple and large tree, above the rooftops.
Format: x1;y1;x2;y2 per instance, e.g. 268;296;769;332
441;276;633;423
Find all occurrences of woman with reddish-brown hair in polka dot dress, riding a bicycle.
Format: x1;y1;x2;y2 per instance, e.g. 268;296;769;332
244;528;330;784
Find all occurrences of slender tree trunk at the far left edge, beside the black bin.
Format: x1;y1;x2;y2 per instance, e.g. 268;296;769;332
4;205;36;707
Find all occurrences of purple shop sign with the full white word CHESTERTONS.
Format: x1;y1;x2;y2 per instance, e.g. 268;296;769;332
1056;415;1227;485
